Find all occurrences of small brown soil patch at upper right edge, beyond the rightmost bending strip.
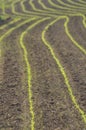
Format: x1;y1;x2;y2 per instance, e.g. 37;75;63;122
68;17;86;48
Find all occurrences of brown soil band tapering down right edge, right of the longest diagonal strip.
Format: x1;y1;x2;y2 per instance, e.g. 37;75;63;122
46;17;86;118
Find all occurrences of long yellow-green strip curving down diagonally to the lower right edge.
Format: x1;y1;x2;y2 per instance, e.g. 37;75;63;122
42;16;86;123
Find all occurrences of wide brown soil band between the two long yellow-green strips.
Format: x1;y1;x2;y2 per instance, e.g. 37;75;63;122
22;18;83;130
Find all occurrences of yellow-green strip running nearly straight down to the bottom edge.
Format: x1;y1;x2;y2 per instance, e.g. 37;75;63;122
20;18;50;130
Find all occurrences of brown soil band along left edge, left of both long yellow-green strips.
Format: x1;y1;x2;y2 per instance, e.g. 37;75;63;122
0;19;37;130
